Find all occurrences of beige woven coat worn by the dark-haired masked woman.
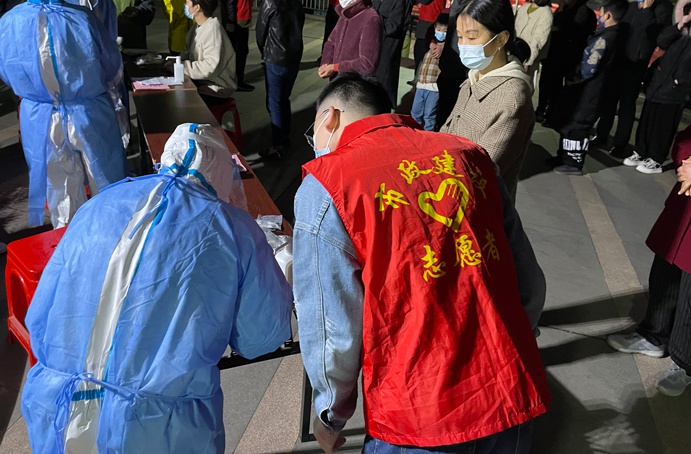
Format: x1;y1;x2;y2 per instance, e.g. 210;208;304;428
441;62;535;201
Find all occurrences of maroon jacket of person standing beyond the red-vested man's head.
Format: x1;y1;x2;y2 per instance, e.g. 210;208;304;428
322;0;382;76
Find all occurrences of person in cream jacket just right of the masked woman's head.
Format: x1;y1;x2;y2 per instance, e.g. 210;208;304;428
516;0;552;83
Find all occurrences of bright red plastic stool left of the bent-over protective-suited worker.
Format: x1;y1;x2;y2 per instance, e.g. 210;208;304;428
5;227;67;366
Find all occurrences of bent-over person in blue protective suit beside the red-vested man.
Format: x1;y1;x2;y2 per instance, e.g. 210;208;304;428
22;124;293;454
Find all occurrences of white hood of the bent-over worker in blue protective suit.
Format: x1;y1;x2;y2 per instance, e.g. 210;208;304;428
159;123;247;210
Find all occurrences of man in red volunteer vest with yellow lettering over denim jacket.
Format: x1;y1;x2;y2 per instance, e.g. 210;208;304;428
294;74;550;453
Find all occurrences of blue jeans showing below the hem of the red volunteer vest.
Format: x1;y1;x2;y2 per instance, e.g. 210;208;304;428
362;421;533;454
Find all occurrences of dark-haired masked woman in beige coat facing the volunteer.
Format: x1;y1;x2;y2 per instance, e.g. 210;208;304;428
441;0;535;201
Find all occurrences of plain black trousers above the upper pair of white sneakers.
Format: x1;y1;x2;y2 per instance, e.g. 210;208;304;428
636;101;684;164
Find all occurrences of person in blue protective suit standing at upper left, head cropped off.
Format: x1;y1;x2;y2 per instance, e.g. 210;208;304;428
0;0;127;228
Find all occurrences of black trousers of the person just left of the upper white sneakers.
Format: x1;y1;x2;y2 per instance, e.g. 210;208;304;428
597;62;648;147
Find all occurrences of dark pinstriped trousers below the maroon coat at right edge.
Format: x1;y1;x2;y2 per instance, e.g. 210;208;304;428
636;255;691;375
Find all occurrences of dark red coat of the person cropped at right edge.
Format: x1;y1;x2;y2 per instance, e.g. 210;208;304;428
646;126;691;273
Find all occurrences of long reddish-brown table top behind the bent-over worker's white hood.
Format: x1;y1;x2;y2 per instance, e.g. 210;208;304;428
134;90;292;235
